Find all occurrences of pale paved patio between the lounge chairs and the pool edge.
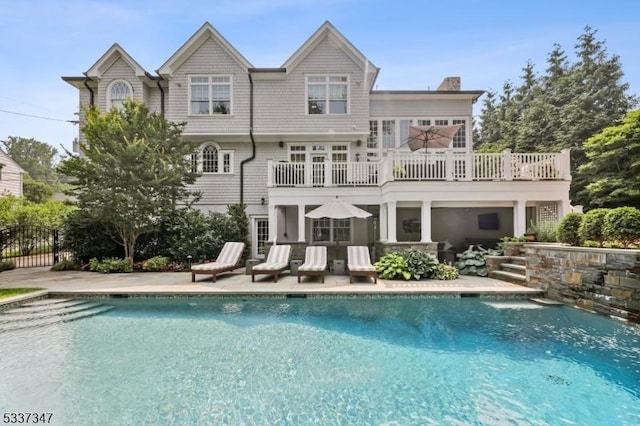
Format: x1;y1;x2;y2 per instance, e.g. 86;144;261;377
0;267;541;303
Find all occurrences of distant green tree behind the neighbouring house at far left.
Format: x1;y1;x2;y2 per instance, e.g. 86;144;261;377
0;136;58;186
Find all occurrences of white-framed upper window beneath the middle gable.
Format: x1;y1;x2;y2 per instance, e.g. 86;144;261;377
189;76;231;115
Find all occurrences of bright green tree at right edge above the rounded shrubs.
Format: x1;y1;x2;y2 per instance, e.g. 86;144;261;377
578;110;640;208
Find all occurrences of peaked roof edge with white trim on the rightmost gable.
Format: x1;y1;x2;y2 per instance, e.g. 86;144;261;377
282;21;380;89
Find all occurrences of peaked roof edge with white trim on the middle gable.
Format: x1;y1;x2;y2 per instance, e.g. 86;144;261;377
157;22;253;77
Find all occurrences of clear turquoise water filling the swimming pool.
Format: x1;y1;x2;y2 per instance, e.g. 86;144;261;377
0;298;640;426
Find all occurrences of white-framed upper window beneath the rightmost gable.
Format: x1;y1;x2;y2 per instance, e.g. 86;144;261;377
307;75;349;114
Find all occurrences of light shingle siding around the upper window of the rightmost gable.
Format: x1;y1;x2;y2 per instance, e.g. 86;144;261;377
254;39;369;133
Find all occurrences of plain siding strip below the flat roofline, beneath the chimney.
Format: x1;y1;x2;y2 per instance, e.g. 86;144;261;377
371;98;473;117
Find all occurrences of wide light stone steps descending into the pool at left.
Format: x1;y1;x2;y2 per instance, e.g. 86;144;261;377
0;299;113;333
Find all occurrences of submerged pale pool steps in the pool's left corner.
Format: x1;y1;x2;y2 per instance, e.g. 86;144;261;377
0;301;113;333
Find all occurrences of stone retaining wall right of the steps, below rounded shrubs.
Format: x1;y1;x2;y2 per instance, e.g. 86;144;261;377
524;244;640;323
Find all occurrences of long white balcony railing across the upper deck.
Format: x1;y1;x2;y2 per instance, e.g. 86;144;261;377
267;150;571;187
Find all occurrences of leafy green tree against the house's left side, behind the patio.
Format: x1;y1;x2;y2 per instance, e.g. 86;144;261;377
59;101;197;259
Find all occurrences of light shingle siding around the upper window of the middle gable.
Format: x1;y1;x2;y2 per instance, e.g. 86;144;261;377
165;38;249;134
